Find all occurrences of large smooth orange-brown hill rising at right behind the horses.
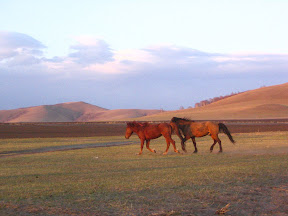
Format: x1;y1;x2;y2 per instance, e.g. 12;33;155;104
139;83;288;120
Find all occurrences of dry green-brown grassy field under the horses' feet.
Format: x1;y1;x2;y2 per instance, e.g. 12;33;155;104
0;132;288;216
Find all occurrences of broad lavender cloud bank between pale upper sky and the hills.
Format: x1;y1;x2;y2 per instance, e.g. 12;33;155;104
0;32;288;109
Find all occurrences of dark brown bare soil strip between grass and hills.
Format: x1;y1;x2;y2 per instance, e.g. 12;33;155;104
0;120;288;139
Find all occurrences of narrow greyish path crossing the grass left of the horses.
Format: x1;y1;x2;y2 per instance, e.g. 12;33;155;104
0;141;133;158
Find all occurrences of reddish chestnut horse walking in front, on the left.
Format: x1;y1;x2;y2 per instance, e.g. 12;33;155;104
125;121;179;155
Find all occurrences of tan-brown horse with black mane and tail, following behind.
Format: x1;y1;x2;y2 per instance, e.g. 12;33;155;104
170;117;235;153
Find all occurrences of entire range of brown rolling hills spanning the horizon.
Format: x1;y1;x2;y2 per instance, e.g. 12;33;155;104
0;83;288;122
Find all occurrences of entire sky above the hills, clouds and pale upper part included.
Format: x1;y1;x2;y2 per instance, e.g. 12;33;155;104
0;0;288;110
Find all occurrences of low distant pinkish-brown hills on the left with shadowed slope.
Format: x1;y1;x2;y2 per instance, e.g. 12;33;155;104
0;102;161;122
